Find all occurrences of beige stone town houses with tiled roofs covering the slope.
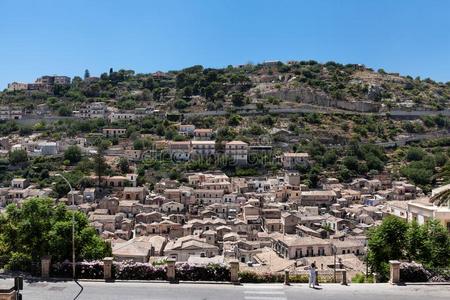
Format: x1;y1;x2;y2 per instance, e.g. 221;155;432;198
0;86;450;277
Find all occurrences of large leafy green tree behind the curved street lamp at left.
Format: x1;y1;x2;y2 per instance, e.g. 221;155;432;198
0;198;111;271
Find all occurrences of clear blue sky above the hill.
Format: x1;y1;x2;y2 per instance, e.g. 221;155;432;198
0;0;450;89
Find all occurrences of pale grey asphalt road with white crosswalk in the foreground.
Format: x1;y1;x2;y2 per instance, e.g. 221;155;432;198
14;282;450;300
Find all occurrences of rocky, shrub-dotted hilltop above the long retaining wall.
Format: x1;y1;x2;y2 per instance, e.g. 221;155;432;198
0;61;450;113
